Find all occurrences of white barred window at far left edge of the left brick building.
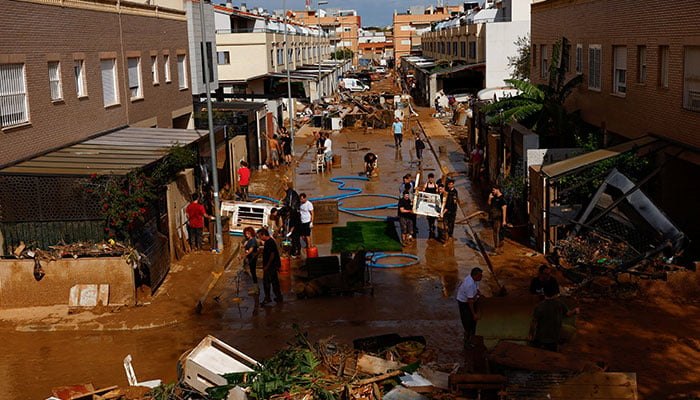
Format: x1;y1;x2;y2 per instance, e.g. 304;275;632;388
0;64;29;128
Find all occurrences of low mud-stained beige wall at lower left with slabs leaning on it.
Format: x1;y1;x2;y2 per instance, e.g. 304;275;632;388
0;257;136;308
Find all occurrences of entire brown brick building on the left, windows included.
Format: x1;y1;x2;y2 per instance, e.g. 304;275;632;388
0;0;192;167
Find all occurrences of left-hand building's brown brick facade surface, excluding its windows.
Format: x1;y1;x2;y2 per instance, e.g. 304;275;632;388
0;0;192;166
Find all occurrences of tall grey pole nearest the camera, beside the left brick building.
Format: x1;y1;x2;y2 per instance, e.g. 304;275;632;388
199;0;224;251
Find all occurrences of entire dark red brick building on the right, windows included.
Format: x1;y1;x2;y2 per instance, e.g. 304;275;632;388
531;0;700;253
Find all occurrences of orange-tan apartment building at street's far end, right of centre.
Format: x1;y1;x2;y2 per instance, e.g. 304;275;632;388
393;6;462;60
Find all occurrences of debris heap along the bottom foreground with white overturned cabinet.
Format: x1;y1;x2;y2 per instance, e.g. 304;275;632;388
47;327;637;400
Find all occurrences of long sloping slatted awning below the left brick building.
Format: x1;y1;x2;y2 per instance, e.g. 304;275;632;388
0;127;208;175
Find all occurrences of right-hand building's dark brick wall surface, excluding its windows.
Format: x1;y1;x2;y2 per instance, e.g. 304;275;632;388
531;0;700;148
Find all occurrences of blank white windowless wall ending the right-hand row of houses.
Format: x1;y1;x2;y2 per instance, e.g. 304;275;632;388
485;21;530;88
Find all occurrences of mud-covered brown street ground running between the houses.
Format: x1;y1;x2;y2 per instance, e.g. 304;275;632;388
0;76;700;399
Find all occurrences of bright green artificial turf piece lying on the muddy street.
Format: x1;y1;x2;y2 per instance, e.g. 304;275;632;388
331;221;401;253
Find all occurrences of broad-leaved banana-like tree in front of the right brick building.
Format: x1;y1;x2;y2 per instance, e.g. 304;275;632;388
487;42;582;146
